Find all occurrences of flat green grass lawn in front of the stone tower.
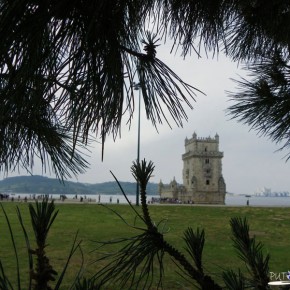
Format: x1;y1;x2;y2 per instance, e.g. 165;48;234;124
0;202;290;289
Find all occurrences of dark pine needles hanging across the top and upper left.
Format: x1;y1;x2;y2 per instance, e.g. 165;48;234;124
0;0;290;178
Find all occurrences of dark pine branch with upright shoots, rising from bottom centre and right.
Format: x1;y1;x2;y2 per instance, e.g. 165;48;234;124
94;160;269;290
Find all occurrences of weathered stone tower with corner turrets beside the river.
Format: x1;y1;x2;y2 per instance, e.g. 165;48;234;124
159;133;226;204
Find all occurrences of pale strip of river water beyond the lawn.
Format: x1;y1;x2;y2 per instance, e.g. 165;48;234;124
5;193;290;207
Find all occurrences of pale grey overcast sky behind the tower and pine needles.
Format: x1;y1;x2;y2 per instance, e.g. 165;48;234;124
2;47;290;194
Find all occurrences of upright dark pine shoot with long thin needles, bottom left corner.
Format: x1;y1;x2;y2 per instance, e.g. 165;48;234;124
0;199;80;290
